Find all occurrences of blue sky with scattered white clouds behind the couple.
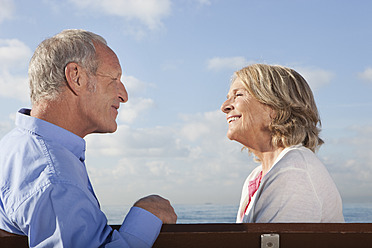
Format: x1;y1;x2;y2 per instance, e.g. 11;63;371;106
0;0;372;205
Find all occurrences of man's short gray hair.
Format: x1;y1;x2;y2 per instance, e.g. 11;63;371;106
28;29;107;104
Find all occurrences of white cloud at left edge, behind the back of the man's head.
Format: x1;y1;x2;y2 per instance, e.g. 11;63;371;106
0;39;32;102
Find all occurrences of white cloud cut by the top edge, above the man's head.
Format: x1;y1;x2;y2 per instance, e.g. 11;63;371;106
71;0;171;30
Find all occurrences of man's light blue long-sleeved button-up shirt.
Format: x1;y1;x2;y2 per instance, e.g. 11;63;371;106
0;109;162;247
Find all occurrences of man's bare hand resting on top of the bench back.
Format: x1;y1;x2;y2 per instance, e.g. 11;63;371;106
133;195;177;224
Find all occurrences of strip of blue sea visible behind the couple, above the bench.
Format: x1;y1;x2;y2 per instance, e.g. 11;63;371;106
102;203;372;225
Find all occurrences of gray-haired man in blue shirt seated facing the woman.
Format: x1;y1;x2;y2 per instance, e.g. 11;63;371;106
0;30;177;247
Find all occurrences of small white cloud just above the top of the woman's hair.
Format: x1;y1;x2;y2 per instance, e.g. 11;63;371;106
207;56;249;70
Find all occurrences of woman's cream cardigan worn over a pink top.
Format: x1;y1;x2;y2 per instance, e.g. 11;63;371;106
236;145;344;223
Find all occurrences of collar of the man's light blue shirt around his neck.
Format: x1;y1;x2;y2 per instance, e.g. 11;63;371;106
16;108;85;162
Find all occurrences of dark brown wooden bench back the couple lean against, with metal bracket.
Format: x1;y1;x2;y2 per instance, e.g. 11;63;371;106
0;223;372;248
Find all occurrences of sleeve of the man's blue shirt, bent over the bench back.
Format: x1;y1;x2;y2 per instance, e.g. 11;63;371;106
14;183;162;248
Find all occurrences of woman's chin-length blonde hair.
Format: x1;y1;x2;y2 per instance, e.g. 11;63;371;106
233;64;324;152
